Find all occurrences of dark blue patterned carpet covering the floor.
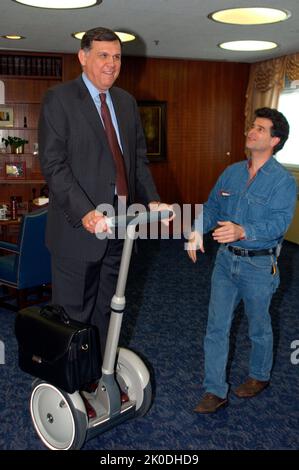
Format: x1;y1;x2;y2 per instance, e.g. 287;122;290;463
0;238;299;451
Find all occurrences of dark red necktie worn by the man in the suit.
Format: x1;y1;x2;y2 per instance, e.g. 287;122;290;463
100;93;128;197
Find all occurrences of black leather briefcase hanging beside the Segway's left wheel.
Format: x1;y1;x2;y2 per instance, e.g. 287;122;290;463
15;305;102;393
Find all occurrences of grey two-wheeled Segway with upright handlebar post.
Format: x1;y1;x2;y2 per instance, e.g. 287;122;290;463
30;211;170;450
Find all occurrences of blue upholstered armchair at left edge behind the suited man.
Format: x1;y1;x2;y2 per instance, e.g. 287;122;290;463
0;209;51;310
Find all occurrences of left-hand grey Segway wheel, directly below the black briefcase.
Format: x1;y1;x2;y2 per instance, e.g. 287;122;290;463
30;380;88;450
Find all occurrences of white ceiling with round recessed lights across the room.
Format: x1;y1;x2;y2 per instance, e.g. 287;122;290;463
0;0;299;62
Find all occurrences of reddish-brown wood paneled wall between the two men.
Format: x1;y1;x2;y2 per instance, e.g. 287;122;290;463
117;57;249;203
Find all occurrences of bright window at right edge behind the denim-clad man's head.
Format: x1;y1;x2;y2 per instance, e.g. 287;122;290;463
276;82;299;170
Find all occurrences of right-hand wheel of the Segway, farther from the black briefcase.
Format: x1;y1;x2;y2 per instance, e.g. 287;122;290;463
116;348;152;416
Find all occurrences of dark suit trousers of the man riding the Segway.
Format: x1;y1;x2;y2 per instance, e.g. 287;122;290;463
52;235;124;356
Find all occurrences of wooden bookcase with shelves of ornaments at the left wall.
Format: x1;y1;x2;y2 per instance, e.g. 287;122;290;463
0;51;63;204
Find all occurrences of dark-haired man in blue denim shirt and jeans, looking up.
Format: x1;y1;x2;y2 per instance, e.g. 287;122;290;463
188;108;297;413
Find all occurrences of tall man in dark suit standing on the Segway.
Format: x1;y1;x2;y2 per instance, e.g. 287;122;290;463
39;28;165;353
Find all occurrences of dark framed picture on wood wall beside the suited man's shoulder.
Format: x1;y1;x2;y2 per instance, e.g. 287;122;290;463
138;101;166;162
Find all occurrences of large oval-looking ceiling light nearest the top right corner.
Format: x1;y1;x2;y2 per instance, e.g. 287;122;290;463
208;7;291;25
